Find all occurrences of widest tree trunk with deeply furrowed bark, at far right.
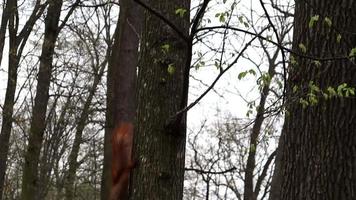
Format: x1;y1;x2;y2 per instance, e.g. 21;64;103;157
270;0;356;200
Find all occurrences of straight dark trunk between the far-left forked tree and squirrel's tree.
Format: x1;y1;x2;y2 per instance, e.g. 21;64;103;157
21;0;63;200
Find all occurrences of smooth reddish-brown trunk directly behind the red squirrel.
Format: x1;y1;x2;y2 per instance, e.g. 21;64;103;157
101;0;142;200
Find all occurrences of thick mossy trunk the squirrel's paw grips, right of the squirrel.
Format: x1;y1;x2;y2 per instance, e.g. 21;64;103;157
130;0;190;200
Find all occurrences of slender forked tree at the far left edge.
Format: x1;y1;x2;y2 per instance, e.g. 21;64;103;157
0;0;47;199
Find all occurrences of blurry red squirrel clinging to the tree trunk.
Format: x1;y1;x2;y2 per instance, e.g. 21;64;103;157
110;122;135;200
